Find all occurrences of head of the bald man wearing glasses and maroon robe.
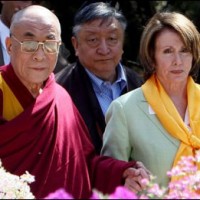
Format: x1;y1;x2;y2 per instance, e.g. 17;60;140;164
6;5;61;87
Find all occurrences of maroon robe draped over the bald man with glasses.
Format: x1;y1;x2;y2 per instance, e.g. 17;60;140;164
0;66;134;198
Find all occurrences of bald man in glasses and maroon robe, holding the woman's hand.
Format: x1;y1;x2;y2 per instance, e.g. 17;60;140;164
0;5;148;198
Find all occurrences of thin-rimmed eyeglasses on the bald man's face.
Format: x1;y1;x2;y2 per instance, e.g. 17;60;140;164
11;35;61;54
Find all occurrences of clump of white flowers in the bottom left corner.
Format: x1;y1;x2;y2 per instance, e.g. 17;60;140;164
0;161;35;199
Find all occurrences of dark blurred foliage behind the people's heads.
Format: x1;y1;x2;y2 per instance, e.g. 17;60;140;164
0;0;200;80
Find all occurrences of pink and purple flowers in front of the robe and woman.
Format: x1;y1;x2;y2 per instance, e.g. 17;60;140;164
46;151;200;199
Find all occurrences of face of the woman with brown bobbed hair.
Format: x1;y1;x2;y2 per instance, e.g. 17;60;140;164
154;29;193;85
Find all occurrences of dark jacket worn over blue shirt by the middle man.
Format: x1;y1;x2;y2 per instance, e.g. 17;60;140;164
56;62;142;154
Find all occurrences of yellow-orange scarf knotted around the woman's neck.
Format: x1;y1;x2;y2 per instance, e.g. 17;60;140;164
142;75;200;180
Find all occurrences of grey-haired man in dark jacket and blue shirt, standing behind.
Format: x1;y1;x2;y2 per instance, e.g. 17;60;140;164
56;2;142;153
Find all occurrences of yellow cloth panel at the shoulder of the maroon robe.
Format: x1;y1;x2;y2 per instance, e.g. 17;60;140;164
0;74;23;121
